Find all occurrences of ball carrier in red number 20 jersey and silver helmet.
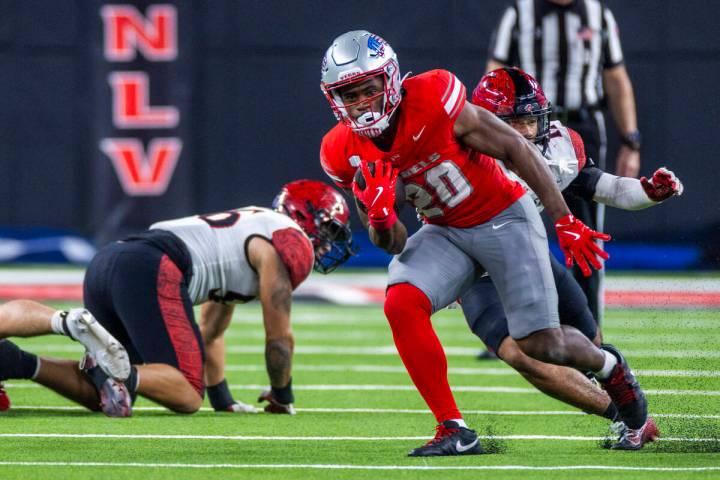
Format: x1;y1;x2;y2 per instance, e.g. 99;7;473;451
320;30;647;456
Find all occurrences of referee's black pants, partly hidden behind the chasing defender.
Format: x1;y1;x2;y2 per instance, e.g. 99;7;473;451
558;111;607;323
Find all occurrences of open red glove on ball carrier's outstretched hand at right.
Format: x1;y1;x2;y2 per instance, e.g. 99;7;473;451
555;215;611;277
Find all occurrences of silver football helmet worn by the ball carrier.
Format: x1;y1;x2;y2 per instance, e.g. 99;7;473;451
320;30;404;137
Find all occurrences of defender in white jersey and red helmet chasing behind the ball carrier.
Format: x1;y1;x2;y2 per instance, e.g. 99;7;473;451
461;68;683;449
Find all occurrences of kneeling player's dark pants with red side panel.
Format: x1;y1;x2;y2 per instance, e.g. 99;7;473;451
83;230;205;395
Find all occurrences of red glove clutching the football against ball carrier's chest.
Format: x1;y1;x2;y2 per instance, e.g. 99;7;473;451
352;160;398;230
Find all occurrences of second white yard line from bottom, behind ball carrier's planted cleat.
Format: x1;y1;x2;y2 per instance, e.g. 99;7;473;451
0;433;720;442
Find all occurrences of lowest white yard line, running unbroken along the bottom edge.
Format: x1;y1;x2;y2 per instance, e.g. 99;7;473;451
0;461;720;472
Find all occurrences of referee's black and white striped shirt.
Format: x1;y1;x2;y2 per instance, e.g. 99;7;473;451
490;0;623;110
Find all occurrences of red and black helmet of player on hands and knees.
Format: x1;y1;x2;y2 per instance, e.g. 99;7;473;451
273;180;357;273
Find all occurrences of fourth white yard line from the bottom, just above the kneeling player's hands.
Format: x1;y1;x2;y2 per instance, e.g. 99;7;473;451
5;383;720;397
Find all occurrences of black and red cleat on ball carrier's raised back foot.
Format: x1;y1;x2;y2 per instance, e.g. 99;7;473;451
598;344;648;430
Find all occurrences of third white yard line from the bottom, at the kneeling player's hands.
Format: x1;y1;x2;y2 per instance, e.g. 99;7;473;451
12;405;720;420
